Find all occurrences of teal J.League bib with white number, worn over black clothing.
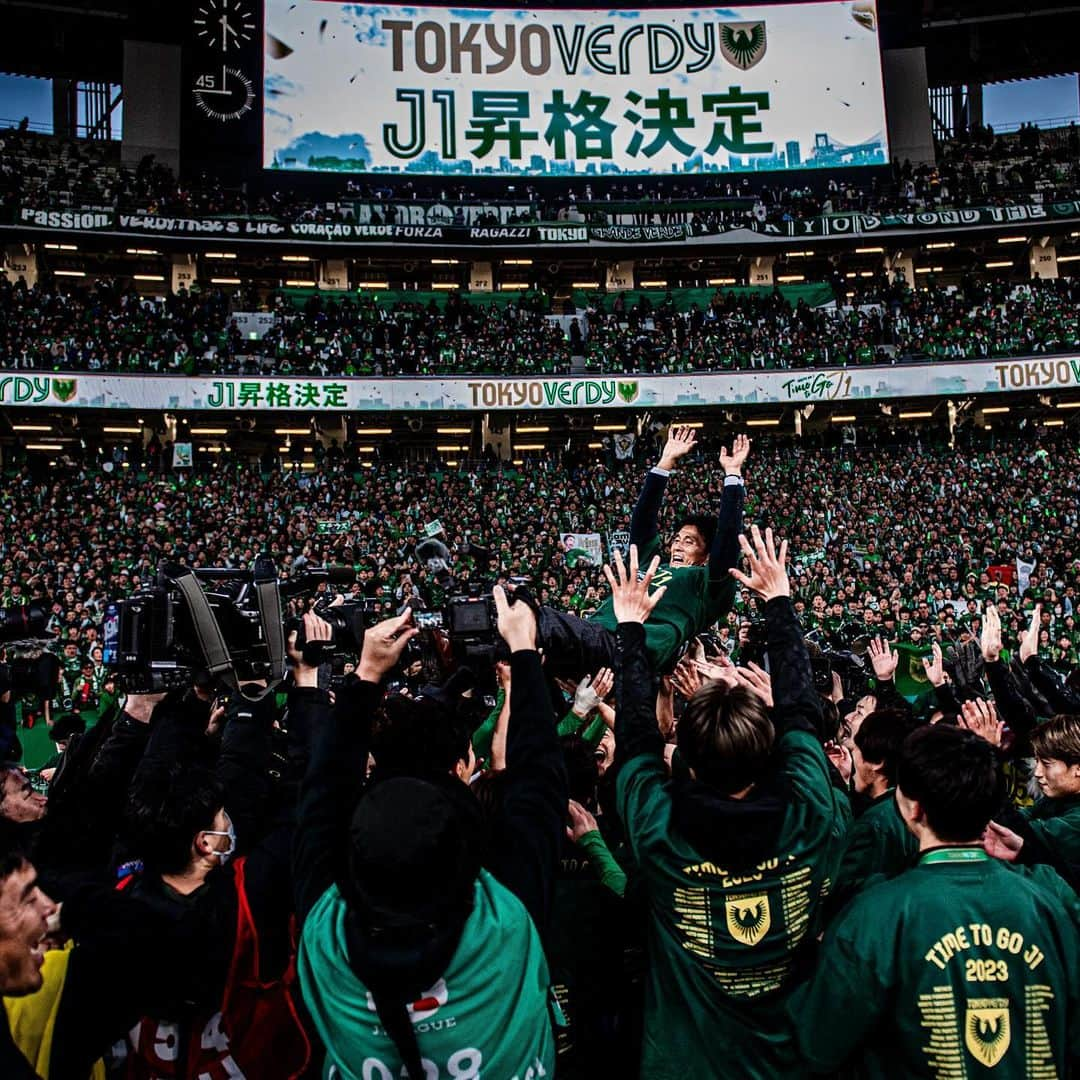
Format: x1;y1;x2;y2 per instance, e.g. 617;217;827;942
298;870;555;1080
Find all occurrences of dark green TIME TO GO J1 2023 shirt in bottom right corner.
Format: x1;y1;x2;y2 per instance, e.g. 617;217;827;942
788;847;1080;1080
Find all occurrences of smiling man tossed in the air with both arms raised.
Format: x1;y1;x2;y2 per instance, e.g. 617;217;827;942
539;427;750;678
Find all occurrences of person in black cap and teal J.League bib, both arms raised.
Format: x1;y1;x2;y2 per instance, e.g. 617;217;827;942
294;588;567;1080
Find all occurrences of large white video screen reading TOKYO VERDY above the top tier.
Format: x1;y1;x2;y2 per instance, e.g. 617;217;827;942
262;0;889;177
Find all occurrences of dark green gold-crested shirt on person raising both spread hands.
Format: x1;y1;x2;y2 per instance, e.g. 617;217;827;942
617;721;846;1080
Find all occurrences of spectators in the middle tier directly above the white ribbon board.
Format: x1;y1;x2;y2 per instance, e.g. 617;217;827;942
6;275;1080;377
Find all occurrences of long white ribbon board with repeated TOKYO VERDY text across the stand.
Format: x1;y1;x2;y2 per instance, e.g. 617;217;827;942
6;354;1080;413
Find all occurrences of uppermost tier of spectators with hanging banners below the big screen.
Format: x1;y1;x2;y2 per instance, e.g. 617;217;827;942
6;125;1080;233
